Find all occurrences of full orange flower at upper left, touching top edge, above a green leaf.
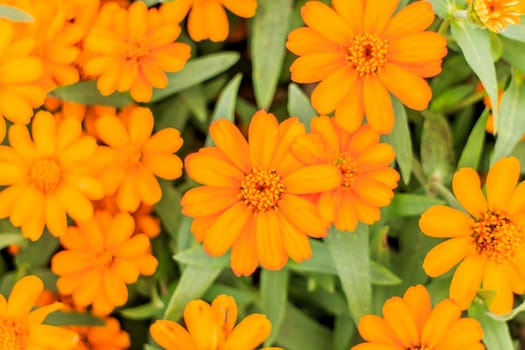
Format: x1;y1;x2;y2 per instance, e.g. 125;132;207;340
84;1;190;102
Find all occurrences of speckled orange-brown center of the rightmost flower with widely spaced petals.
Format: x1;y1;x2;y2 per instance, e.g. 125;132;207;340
472;211;524;263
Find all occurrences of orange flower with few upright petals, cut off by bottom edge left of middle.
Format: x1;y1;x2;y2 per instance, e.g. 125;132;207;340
150;294;279;350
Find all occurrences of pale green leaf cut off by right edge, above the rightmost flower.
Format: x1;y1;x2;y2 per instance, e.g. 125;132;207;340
491;79;525;164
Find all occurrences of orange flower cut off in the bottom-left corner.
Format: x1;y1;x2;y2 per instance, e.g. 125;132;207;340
0;276;79;350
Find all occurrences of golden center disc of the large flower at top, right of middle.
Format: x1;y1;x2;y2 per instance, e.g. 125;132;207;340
346;33;388;77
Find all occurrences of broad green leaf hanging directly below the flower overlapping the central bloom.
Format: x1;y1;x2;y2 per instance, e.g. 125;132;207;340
324;224;372;322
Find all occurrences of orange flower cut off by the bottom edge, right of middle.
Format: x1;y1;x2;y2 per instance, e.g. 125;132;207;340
352;284;485;350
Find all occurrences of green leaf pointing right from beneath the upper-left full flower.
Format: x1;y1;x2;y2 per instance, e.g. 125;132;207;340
150;52;240;102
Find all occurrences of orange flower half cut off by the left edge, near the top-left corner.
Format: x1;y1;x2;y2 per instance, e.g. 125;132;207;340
0;19;46;142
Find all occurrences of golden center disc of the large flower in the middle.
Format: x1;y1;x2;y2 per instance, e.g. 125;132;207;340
239;169;284;214
